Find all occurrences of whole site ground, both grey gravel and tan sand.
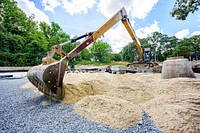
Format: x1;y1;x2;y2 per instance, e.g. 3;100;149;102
0;69;200;132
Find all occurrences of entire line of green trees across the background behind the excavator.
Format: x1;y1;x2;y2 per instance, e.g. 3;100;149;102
0;0;200;66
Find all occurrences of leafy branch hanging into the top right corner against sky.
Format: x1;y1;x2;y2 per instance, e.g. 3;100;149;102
170;0;200;20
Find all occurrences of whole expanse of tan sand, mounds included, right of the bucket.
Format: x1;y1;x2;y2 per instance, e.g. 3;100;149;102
25;73;200;132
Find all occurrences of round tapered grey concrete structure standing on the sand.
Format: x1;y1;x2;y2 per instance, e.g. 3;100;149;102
161;59;196;79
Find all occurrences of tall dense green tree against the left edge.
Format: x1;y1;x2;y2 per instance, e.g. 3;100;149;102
0;0;48;66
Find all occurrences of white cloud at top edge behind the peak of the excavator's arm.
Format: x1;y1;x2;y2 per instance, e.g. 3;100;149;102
98;0;158;19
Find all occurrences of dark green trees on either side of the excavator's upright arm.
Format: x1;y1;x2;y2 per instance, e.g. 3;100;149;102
120;32;200;62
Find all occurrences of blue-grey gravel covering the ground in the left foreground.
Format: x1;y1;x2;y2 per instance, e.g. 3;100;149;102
0;75;161;133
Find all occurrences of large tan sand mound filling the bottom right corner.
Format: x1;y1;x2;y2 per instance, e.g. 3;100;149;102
144;91;200;133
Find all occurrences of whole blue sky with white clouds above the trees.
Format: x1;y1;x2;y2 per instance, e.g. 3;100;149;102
16;0;200;52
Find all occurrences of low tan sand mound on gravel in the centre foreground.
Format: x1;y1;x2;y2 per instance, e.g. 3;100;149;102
74;95;141;129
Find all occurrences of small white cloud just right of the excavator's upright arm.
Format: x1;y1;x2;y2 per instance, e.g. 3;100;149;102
136;21;161;38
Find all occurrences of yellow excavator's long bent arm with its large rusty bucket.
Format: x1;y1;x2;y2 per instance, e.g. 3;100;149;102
27;8;143;101
